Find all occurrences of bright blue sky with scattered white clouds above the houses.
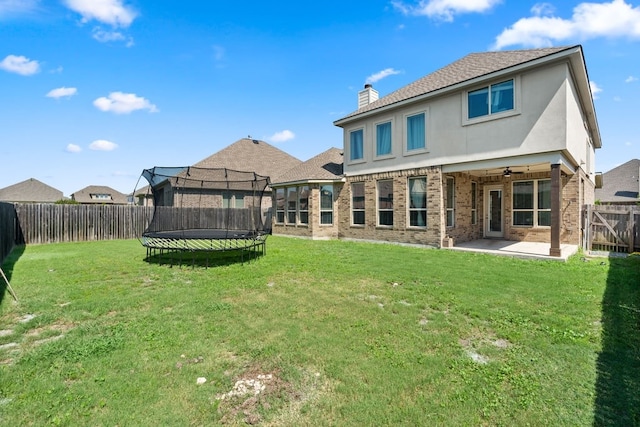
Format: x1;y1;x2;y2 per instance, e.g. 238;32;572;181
0;0;640;196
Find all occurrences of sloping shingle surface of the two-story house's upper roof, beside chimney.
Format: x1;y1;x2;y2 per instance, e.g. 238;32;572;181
334;47;574;124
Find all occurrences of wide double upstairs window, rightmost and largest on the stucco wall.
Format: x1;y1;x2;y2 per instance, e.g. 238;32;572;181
467;79;515;119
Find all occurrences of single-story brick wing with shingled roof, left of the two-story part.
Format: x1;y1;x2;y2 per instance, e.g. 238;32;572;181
271;148;343;239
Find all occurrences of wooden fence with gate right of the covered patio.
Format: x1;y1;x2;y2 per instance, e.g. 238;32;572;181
583;205;640;253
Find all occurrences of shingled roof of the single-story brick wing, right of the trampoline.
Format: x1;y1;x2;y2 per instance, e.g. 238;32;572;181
274;148;343;184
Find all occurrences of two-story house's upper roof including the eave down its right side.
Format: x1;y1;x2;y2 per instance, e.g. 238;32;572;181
334;46;601;147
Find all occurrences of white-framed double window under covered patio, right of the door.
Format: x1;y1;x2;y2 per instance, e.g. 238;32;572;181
512;179;551;227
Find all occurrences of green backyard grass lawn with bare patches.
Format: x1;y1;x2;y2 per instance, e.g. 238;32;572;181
0;236;640;426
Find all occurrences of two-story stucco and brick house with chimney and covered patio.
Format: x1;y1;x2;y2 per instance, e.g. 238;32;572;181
278;46;601;256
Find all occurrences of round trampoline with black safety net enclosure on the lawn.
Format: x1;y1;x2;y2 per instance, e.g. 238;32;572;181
134;166;271;265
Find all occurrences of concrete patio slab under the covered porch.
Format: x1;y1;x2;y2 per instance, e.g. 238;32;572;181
445;239;578;262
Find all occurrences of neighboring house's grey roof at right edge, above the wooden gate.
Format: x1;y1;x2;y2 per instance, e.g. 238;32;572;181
595;159;640;205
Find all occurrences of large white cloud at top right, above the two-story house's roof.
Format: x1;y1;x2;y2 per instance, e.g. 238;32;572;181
493;0;640;49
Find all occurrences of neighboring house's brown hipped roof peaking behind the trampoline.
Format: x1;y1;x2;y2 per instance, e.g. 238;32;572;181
193;138;302;181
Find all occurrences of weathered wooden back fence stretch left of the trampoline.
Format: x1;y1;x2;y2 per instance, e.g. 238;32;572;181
15;203;153;244
